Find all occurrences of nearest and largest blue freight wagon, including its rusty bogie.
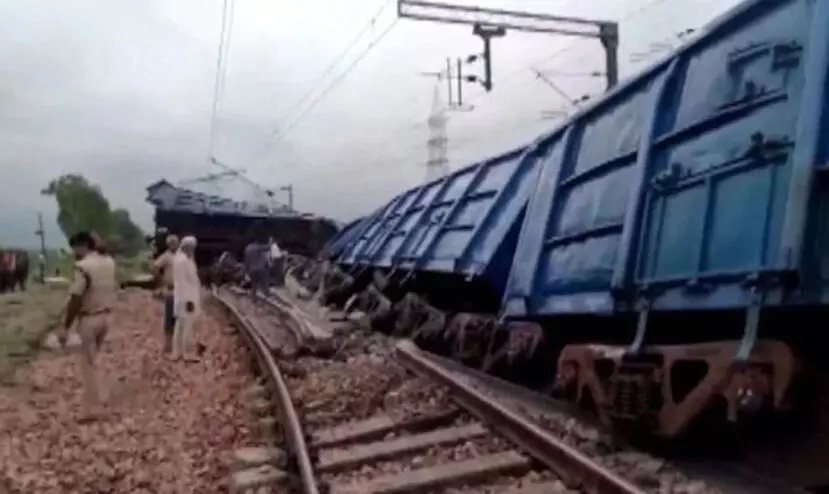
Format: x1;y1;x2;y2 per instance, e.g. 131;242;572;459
492;0;829;448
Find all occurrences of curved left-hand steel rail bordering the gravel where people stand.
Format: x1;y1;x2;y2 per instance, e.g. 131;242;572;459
213;289;320;494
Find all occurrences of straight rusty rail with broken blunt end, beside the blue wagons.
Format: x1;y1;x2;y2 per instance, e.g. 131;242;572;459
395;340;645;494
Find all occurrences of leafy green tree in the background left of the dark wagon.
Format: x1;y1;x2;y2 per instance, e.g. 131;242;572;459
41;173;144;255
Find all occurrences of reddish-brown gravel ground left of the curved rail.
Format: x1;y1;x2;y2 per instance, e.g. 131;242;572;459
0;289;253;494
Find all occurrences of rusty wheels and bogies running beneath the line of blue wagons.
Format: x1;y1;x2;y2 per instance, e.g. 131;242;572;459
290;264;820;438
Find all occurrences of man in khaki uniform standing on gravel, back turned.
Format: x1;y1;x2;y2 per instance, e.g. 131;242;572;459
57;232;118;421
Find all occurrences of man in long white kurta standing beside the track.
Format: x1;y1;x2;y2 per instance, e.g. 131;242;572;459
172;237;201;362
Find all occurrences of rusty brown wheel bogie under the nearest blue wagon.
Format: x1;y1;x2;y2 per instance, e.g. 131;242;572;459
558;339;802;437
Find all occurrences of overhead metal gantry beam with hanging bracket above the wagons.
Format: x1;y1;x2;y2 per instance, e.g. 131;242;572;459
397;0;619;91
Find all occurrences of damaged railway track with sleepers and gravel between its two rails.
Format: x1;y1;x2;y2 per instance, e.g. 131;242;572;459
218;290;768;494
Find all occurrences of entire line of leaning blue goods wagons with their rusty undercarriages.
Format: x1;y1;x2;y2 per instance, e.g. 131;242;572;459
296;0;829;485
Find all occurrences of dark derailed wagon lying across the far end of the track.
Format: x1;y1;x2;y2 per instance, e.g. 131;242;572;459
147;180;338;269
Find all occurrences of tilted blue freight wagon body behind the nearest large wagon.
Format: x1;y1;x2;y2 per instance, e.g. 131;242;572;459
337;144;543;311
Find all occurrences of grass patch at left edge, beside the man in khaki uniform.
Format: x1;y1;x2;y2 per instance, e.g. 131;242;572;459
0;285;66;384
